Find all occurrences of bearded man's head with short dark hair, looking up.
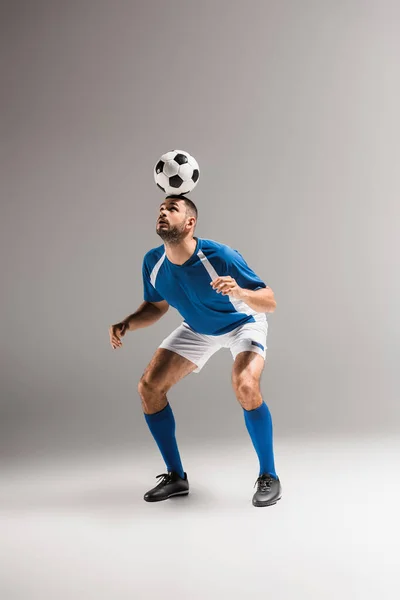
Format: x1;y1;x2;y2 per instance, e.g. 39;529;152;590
156;196;197;244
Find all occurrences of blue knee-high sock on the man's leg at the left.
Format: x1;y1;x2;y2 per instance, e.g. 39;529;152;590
143;403;184;477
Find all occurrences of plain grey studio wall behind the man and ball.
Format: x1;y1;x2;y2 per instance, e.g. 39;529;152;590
0;0;400;460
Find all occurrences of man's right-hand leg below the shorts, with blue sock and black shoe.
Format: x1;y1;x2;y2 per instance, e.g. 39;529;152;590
232;351;280;506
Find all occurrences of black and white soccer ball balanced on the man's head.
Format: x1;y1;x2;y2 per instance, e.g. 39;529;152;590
154;150;200;195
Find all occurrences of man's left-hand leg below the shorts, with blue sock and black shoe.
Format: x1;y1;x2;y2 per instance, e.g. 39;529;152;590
138;348;196;501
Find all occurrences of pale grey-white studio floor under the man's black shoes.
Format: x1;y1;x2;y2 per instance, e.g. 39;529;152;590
0;438;400;600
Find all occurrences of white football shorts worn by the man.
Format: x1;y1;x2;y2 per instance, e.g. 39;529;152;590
159;321;268;373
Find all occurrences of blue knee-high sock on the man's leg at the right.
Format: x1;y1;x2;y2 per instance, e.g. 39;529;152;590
243;401;277;479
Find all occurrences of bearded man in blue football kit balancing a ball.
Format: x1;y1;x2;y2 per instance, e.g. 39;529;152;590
109;195;282;506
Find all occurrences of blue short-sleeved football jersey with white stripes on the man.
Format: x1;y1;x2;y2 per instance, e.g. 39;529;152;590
142;237;267;335
